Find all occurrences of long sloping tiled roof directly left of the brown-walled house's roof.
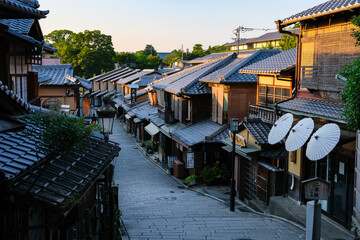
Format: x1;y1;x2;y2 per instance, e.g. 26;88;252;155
153;55;232;94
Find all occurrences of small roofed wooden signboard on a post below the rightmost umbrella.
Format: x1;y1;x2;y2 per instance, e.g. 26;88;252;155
302;178;331;200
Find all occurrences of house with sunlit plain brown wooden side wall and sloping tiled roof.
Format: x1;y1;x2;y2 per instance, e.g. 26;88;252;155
200;49;281;124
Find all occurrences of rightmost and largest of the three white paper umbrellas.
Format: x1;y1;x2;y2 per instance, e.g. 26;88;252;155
306;123;340;161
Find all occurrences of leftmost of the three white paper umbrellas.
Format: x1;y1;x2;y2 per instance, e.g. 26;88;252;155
268;113;294;145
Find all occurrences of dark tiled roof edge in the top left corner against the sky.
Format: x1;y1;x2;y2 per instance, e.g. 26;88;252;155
0;0;49;18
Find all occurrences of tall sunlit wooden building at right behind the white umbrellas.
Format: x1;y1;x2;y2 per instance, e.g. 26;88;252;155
276;0;360;228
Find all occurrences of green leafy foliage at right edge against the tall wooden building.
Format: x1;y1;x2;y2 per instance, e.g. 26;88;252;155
340;16;360;130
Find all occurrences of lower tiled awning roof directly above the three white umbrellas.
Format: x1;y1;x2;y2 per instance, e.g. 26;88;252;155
277;98;344;122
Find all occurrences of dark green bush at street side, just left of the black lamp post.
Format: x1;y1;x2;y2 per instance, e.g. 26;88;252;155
200;161;230;185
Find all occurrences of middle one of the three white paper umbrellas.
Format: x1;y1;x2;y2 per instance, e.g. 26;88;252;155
285;118;314;152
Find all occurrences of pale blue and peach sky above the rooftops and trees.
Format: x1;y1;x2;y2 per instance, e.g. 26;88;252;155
38;0;325;52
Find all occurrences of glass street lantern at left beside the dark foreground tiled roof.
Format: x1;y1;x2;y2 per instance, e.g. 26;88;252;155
96;98;116;142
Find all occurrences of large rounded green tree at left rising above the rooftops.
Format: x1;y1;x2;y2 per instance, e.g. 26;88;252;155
45;30;115;78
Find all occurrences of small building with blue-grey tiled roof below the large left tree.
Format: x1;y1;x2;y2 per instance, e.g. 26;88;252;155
33;64;91;115
